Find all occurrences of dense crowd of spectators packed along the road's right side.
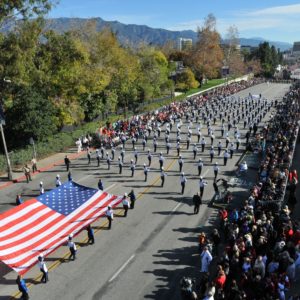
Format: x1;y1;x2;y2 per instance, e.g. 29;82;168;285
198;85;300;300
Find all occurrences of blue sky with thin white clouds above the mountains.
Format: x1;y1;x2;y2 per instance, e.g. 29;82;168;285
50;0;300;43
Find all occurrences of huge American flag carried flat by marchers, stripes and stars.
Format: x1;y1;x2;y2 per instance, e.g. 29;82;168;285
0;181;122;274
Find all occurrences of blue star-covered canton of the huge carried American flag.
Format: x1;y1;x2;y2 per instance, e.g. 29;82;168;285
37;181;98;216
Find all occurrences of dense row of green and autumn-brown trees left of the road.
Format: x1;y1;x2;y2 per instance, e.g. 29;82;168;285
0;9;281;149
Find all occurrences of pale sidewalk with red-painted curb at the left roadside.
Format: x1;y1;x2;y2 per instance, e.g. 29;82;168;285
0;148;86;190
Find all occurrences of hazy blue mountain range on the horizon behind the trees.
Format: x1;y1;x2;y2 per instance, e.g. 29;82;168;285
1;18;292;51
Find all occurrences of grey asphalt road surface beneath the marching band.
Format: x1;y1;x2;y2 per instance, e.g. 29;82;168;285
0;84;289;300
